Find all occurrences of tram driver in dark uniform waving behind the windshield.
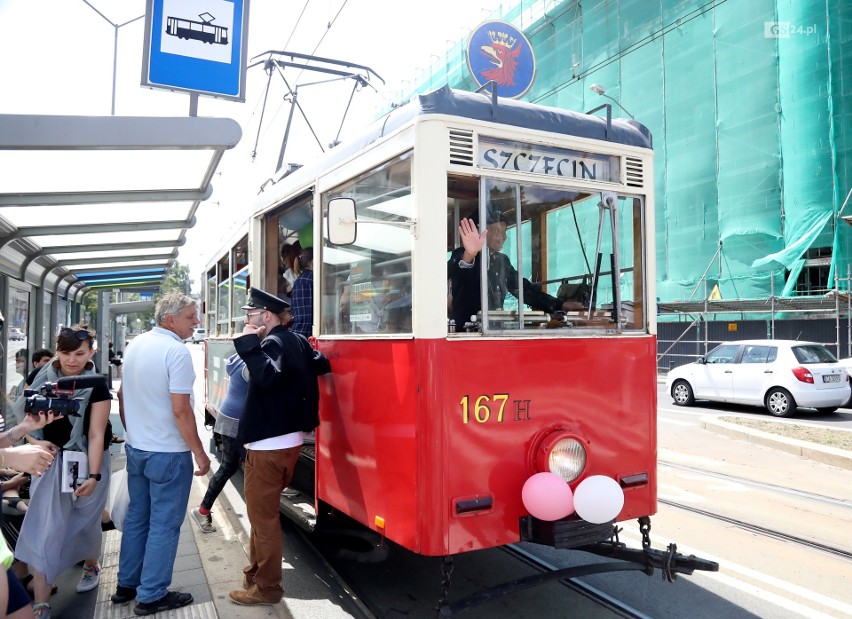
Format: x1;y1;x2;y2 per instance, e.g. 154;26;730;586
447;205;583;331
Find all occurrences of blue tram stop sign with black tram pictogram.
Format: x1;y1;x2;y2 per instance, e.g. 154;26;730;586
142;0;249;101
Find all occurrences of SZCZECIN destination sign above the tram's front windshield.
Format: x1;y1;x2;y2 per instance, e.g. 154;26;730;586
478;137;620;183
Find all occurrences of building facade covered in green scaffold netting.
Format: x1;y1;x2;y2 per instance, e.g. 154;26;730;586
402;0;852;320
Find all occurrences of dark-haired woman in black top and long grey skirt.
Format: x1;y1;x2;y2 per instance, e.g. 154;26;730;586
15;325;112;618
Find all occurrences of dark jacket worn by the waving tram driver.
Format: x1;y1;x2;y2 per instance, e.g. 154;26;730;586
447;247;562;331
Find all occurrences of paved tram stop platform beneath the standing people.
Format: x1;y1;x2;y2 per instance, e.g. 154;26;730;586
81;381;354;619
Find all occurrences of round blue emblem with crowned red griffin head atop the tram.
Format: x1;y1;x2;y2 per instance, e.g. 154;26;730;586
467;21;535;99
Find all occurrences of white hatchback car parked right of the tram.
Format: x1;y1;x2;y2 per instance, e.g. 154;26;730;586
666;340;850;417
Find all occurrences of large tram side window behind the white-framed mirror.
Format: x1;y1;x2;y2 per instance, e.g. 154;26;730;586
320;153;414;335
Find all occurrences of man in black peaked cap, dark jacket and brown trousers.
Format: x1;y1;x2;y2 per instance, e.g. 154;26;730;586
230;288;331;606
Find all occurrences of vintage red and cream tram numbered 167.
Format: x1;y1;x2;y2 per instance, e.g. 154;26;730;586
206;88;712;596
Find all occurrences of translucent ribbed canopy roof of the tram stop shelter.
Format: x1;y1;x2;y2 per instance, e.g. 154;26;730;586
0;114;241;298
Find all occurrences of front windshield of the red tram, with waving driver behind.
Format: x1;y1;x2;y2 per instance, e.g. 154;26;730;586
447;177;645;335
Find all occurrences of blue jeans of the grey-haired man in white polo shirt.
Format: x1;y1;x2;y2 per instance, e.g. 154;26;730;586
118;444;193;602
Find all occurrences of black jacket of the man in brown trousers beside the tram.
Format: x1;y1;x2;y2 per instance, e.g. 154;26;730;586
234;326;331;443
